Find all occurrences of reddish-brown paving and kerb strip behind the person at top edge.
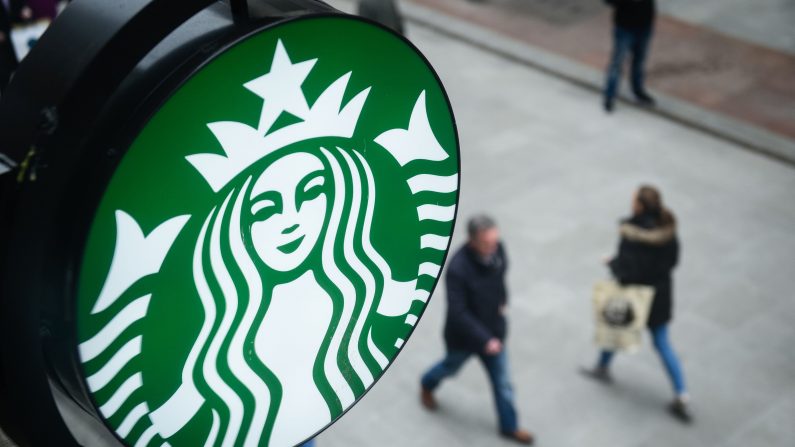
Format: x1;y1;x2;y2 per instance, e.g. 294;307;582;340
403;0;795;163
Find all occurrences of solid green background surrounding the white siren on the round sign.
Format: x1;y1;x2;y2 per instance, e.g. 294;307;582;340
77;16;459;446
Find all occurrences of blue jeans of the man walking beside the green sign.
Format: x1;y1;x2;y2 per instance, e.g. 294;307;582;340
422;349;517;433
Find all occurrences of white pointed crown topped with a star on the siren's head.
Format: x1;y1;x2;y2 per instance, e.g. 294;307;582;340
185;40;370;192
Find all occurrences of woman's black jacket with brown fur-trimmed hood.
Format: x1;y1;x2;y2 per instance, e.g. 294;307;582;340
609;215;679;327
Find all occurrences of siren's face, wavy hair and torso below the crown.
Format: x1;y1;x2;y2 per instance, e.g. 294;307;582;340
177;148;401;445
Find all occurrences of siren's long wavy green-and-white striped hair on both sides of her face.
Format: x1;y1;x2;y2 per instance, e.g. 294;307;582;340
183;147;398;445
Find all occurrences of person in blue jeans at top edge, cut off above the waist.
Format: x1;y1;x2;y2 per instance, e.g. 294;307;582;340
604;0;655;113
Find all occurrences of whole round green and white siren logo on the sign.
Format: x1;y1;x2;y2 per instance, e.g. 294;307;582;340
77;17;459;446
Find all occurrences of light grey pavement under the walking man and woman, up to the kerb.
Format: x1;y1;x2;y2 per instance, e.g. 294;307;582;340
318;4;795;447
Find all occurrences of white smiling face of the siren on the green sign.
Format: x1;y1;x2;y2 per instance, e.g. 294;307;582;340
251;152;327;272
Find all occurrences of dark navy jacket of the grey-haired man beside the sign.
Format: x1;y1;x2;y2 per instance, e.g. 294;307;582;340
444;244;508;353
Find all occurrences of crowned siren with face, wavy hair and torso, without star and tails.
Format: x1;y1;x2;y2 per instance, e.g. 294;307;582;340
147;42;416;445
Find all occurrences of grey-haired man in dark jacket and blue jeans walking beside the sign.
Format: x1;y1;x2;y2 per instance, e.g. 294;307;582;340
421;216;533;444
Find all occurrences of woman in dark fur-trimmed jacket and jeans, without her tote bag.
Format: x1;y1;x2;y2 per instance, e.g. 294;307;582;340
582;186;691;422
